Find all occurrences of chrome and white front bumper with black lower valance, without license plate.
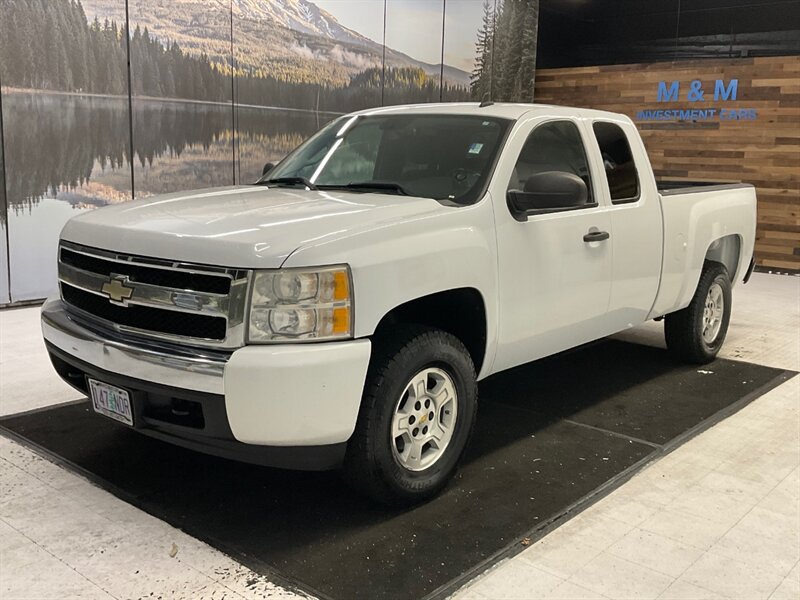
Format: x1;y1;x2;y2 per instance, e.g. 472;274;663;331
42;299;371;469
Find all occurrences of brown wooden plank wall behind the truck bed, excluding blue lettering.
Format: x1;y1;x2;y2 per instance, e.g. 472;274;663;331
536;56;800;270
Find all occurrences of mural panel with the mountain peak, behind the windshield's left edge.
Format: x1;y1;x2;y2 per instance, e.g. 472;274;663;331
233;0;384;183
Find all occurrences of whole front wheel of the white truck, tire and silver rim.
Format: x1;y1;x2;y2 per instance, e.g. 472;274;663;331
344;326;477;506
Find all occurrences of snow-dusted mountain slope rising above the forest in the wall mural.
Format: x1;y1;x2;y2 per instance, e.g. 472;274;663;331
83;0;470;86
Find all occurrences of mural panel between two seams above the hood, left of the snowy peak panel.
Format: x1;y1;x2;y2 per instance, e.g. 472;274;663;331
129;0;234;198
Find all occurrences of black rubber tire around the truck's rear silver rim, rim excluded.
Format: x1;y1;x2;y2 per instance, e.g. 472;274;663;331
664;261;731;365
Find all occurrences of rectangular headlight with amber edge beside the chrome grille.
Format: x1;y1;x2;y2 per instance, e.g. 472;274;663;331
248;267;353;343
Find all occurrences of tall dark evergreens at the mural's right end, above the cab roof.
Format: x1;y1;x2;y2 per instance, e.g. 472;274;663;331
470;0;539;102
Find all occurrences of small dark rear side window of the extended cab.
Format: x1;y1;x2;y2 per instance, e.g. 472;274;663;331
593;121;639;204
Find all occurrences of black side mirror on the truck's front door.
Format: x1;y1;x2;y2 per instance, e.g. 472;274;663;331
507;171;589;221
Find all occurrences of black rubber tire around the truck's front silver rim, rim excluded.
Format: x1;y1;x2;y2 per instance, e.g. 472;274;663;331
343;325;478;506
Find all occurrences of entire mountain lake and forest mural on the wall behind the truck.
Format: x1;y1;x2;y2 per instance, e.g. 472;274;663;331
0;0;538;304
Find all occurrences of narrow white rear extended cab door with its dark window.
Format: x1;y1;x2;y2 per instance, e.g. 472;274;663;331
585;115;664;332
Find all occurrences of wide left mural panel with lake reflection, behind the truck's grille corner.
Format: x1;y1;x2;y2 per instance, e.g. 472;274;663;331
0;0;131;301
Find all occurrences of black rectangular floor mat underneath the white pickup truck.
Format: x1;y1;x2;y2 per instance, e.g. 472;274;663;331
0;341;791;600
